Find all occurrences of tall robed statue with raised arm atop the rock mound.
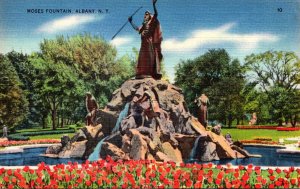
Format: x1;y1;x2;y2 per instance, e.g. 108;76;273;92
128;0;163;79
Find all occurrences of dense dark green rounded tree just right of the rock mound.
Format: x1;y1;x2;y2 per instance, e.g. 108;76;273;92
175;49;245;126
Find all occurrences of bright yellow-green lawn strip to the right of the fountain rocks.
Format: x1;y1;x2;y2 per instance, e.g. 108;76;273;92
222;128;300;142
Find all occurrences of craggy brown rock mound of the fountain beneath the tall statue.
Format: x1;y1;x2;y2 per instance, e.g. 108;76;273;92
47;78;246;162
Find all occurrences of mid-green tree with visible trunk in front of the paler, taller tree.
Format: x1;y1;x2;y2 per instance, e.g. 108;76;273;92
30;55;84;130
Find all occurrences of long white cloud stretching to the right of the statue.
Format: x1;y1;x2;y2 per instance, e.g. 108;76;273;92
162;23;279;52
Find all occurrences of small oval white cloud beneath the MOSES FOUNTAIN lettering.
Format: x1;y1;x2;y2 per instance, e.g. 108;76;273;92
37;15;101;33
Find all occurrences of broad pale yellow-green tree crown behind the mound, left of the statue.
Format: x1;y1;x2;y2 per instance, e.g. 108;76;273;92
40;34;134;107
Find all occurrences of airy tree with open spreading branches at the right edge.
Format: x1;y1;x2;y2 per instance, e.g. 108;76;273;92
245;51;300;126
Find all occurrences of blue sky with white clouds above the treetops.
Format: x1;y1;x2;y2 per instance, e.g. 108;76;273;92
0;0;300;81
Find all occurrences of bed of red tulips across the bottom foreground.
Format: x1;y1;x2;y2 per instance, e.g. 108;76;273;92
0;158;300;188
